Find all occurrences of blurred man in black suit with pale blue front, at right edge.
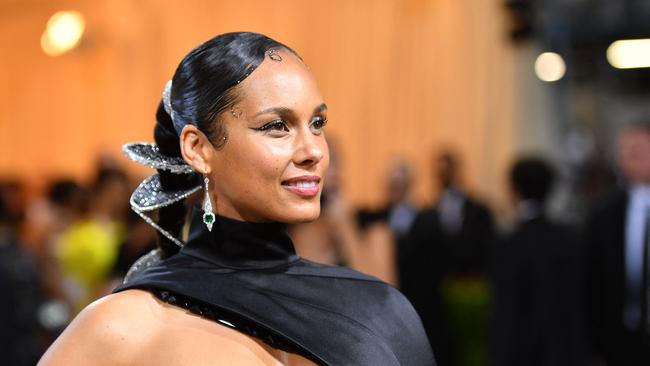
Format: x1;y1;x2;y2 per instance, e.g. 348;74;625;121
585;124;650;366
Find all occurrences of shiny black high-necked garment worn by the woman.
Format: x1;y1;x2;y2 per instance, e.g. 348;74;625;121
116;210;435;366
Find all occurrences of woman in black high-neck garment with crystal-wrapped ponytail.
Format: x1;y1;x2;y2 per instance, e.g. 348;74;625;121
41;33;435;365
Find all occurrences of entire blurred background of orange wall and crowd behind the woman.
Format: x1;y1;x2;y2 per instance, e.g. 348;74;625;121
0;0;650;366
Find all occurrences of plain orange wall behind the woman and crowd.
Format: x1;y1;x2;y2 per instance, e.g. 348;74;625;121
0;0;514;209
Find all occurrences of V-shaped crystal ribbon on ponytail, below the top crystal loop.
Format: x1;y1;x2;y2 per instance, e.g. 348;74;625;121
130;174;201;247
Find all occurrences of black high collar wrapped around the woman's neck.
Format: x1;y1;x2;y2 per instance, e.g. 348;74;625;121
181;208;300;269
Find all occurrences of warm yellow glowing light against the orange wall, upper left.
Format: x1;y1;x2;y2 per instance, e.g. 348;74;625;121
41;11;86;56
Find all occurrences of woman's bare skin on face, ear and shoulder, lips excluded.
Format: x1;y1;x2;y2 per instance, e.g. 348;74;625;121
39;50;329;366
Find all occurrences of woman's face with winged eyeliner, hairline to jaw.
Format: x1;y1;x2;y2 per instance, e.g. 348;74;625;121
208;50;329;223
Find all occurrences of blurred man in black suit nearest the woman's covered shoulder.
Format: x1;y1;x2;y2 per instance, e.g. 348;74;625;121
398;152;493;365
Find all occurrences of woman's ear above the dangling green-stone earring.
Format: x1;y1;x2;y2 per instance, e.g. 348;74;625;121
180;124;214;175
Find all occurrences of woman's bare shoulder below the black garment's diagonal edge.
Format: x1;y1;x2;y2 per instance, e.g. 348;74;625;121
39;290;277;366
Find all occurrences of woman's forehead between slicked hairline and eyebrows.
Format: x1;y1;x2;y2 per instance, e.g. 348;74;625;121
238;49;323;110
